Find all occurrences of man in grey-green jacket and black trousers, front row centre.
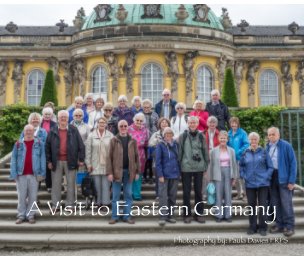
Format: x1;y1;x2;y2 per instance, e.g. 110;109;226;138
178;116;209;223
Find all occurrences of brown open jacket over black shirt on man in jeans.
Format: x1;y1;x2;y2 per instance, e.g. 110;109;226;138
106;135;140;182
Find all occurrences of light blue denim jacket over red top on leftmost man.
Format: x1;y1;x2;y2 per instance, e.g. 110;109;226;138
9;138;46;180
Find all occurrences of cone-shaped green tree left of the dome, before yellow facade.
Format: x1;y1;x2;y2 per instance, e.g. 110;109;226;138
40;69;58;106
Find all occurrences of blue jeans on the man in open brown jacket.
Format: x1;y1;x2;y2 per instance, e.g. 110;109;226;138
112;169;133;220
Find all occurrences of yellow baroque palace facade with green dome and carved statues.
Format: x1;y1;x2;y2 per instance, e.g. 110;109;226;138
0;4;304;107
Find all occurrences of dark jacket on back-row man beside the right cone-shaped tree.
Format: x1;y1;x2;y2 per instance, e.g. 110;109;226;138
206;101;230;131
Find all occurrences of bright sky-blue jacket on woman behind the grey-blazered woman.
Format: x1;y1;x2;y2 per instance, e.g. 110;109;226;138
228;128;249;161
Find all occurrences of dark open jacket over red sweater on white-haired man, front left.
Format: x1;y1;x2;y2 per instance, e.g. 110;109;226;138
45;125;85;171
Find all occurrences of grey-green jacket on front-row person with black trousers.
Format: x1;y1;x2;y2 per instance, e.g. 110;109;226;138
179;131;209;172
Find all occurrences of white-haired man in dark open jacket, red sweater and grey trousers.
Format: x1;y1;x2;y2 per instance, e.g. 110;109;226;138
45;110;85;212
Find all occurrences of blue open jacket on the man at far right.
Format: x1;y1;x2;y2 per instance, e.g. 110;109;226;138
266;139;297;184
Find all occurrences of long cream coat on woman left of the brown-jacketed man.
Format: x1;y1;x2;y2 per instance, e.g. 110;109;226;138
85;130;114;175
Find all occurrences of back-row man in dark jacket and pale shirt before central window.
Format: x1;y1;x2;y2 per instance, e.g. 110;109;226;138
155;89;177;120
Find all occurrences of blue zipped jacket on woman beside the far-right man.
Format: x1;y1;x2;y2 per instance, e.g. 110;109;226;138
240;147;273;188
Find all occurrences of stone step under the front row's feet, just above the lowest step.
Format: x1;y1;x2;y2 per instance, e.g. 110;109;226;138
0;217;304;234
